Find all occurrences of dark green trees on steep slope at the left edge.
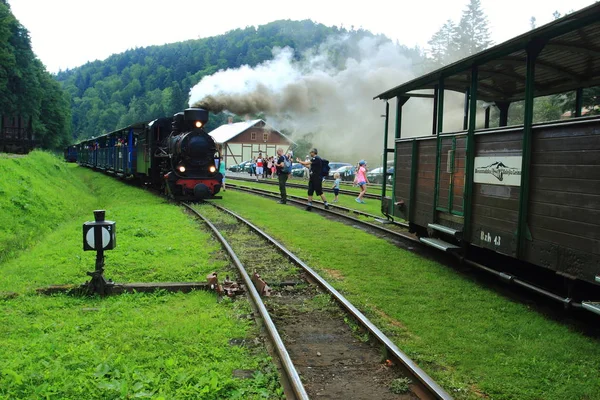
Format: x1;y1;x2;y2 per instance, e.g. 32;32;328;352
0;0;71;148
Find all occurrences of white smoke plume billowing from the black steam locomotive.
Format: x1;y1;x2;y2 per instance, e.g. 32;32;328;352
190;37;462;163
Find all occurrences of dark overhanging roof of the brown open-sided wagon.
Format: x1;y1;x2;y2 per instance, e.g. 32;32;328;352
375;3;600;102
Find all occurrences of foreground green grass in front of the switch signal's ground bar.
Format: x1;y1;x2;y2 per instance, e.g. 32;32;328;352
0;292;279;399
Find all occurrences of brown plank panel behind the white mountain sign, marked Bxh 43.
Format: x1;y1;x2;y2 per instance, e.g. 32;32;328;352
470;130;523;257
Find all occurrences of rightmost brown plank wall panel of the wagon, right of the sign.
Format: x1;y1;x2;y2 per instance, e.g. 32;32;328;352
526;119;600;281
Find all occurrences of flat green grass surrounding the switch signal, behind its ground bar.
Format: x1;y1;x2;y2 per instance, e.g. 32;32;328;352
0;159;230;292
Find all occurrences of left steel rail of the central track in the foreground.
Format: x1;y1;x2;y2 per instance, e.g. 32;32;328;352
182;203;309;400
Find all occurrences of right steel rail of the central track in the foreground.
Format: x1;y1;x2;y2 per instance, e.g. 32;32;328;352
210;203;452;399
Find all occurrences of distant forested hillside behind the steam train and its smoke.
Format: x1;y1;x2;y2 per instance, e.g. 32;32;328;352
58;21;370;138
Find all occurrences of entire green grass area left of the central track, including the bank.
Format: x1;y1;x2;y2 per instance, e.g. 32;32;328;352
0;152;280;399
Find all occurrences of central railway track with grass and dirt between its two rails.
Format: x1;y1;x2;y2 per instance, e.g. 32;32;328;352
184;204;451;399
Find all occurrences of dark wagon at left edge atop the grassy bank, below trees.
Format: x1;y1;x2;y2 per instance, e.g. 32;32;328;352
0;116;36;154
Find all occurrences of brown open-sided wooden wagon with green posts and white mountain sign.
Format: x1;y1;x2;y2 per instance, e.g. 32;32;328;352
376;4;600;312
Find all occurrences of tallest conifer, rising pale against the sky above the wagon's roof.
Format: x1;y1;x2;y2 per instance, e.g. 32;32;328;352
457;0;493;58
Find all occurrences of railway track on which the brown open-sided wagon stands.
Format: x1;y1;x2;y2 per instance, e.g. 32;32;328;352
229;185;595;313
